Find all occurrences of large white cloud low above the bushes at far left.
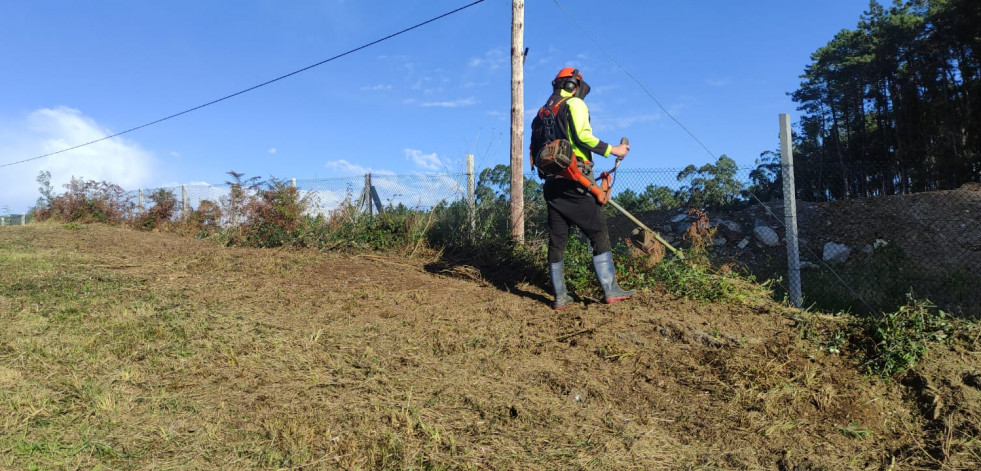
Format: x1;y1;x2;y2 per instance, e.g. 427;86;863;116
0;107;156;212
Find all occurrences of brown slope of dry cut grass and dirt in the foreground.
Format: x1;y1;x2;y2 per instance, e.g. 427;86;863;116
0;224;981;470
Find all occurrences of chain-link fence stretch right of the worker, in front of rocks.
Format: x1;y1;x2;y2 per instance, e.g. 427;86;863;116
592;164;981;317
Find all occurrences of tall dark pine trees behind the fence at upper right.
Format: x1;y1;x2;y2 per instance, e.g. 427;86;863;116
792;0;981;201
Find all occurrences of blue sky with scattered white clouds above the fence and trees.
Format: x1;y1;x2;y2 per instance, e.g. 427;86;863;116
0;0;868;213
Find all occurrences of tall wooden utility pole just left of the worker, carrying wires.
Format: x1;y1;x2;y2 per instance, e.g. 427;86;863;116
511;0;525;244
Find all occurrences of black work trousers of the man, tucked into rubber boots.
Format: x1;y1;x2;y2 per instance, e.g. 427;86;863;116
543;178;610;263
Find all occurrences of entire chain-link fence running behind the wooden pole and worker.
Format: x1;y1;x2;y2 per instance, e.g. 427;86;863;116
88;159;981;316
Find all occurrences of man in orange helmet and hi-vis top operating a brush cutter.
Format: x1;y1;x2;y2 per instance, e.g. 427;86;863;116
530;67;634;309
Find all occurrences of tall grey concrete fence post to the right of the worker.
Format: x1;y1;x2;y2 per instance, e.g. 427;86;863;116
780;113;803;308
